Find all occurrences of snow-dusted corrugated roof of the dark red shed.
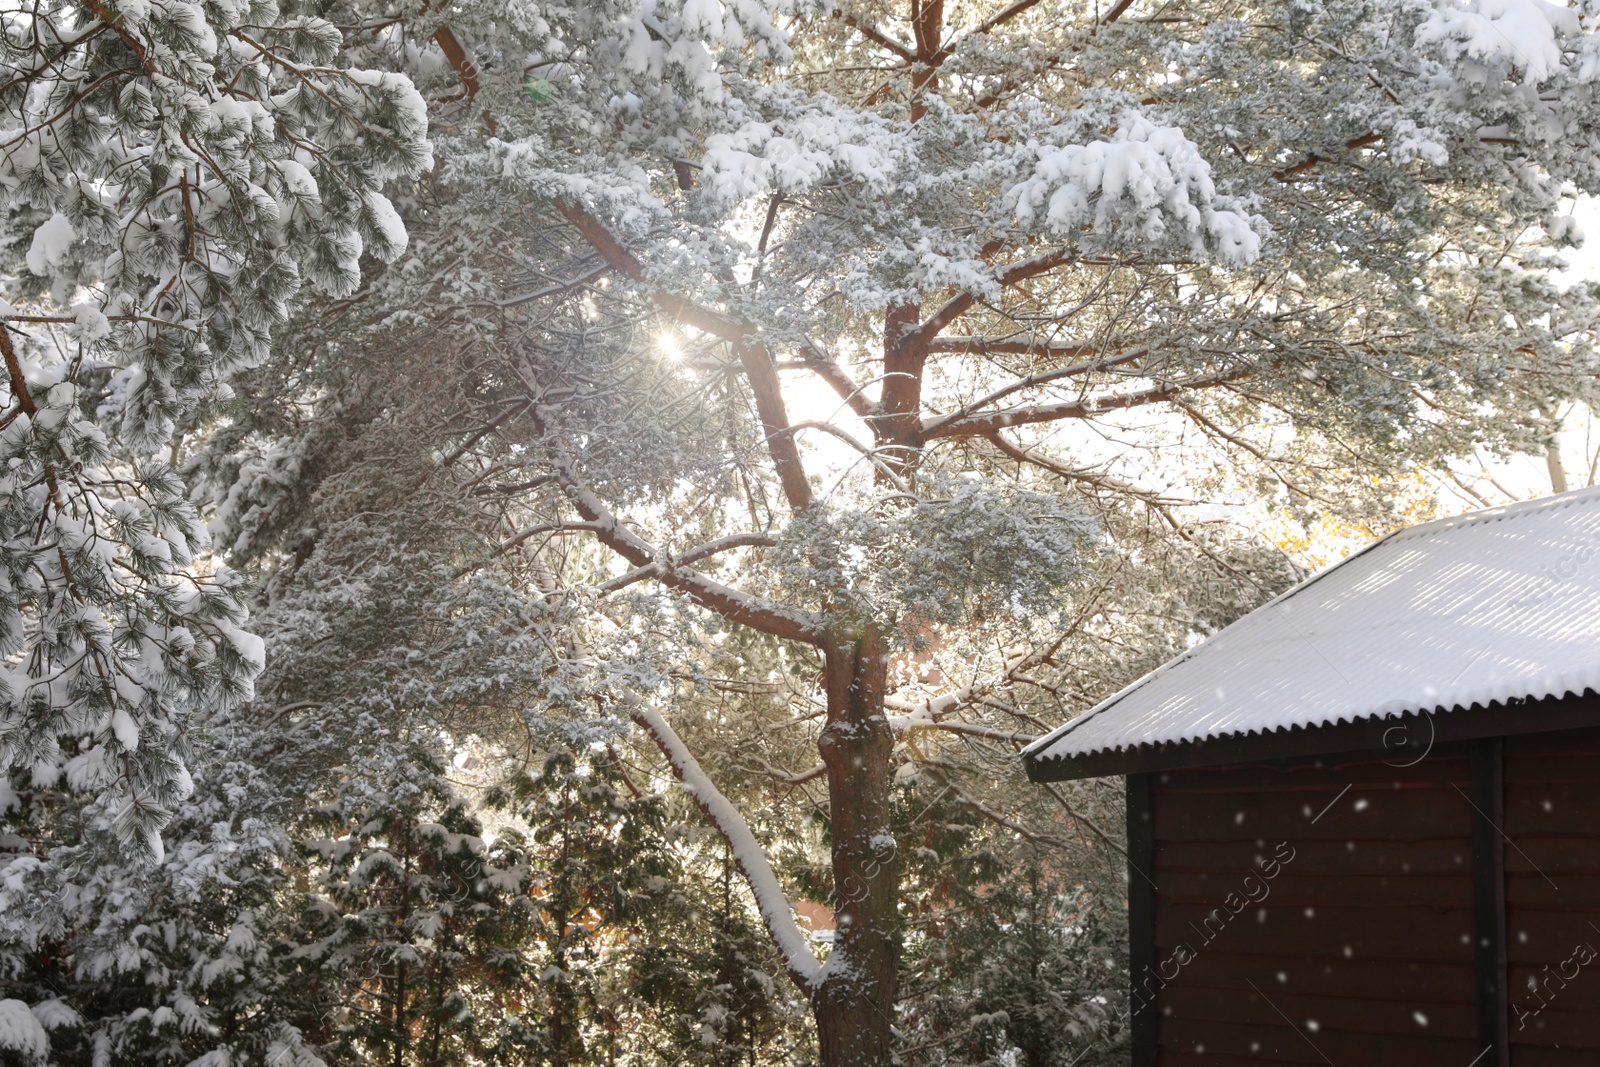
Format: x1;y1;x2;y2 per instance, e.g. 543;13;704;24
1022;488;1600;761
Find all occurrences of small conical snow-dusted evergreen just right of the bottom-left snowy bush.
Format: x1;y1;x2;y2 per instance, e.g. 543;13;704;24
278;739;544;1067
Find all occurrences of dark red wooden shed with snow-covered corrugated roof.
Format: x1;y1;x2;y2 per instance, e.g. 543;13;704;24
1024;490;1600;1067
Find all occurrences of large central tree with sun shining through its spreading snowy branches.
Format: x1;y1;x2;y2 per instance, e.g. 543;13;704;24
96;0;1600;1065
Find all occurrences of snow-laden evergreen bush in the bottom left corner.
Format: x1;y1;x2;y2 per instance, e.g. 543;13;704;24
0;703;346;1067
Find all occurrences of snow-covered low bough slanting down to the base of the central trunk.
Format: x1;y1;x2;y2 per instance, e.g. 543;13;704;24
630;702;822;990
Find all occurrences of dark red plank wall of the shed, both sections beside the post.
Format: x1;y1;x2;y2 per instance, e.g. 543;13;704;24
1134;731;1600;1067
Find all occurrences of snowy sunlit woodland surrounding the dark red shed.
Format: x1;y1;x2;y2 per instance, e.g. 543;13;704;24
0;0;1600;1067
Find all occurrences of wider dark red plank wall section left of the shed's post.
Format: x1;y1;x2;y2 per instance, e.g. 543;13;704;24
1152;744;1480;1067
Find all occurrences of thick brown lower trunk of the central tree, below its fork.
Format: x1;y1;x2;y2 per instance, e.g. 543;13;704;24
811;625;899;1067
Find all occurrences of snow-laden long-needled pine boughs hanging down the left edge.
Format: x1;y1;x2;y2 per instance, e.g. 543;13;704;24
0;0;430;851
